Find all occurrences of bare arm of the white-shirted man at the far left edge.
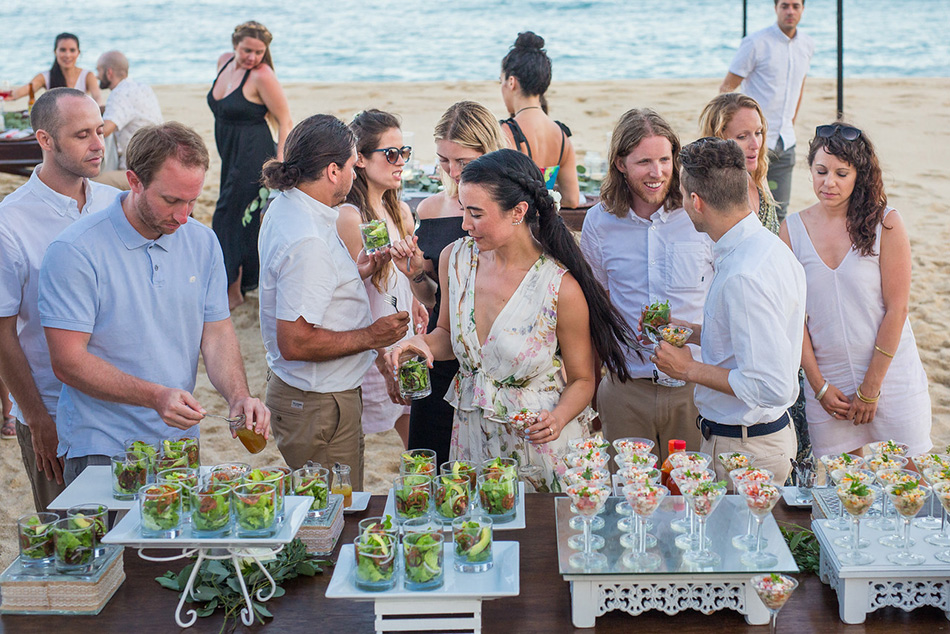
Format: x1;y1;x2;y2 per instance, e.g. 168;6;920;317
0;315;63;484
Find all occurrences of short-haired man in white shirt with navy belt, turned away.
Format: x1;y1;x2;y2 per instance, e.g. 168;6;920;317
654;137;805;484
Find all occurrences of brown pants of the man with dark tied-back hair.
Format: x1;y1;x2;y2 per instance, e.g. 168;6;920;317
265;372;363;491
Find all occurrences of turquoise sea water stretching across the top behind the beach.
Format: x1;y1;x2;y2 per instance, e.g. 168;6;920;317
0;0;950;84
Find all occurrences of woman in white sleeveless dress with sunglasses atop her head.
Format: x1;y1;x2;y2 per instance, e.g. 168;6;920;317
779;123;931;455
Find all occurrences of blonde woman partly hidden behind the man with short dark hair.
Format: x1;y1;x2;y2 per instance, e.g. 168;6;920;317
699;92;778;234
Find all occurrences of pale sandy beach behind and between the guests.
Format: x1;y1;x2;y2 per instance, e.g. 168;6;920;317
0;78;950;567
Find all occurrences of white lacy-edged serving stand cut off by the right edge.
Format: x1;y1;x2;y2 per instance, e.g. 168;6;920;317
812;520;950;624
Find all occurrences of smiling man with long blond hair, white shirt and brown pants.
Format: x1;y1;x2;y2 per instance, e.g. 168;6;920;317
581;109;713;461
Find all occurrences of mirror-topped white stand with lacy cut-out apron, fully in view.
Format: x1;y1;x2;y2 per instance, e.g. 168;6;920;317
555;495;798;628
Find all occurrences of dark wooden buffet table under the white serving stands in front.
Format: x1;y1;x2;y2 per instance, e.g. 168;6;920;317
0;494;950;634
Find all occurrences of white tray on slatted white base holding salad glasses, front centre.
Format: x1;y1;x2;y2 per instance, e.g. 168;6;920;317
326;542;520;634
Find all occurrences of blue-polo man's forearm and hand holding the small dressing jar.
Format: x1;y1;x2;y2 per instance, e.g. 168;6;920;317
201;318;270;438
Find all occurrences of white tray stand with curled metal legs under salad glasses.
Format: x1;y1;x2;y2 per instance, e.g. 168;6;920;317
102;495;313;628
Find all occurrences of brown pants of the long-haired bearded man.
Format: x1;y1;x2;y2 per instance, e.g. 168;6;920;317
596;374;703;464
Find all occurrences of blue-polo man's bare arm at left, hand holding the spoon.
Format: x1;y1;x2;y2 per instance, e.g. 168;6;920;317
45;328;205;429
